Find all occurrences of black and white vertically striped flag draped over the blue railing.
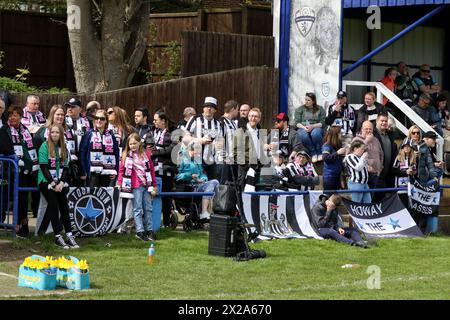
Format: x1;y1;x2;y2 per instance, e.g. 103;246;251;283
242;169;322;240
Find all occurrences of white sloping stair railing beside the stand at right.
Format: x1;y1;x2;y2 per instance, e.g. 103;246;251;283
342;80;444;160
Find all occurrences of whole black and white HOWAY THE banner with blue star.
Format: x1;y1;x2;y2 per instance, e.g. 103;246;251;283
342;194;423;239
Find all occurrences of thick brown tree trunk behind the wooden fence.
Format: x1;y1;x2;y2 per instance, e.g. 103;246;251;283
67;0;150;94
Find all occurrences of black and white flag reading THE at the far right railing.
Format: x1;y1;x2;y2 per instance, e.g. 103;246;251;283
408;177;441;216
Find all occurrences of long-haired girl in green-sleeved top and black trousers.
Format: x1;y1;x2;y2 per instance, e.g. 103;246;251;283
38;124;79;249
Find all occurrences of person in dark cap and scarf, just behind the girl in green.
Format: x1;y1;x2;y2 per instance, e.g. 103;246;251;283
64;98;90;187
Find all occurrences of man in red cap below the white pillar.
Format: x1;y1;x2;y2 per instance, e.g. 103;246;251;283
265;112;303;160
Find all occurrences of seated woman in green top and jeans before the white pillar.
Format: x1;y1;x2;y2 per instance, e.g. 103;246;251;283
294;92;325;163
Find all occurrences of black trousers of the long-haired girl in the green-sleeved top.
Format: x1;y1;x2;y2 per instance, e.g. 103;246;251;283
38;183;72;235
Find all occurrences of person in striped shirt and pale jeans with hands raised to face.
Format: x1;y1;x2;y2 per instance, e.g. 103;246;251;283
344;140;372;203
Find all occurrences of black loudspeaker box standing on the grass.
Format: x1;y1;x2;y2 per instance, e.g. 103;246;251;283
208;214;238;257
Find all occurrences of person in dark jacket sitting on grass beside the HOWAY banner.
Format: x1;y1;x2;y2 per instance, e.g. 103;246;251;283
311;194;367;248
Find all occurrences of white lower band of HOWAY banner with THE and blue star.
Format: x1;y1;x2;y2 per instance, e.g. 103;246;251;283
352;209;416;234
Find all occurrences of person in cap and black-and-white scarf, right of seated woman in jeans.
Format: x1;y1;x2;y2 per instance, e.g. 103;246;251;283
325;90;356;146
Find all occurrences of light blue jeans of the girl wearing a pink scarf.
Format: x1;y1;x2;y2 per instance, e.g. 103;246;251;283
133;186;153;232
